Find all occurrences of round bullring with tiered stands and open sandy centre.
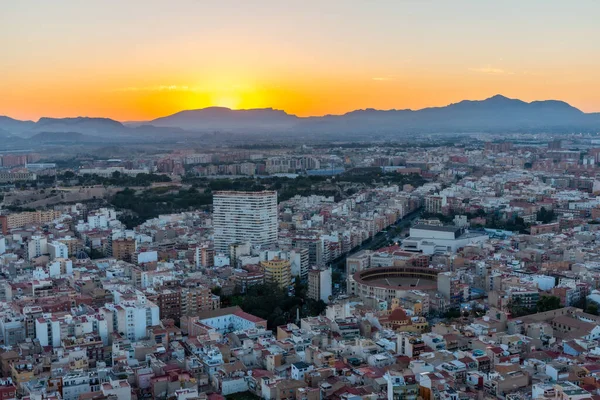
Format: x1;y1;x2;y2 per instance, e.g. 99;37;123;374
348;267;439;301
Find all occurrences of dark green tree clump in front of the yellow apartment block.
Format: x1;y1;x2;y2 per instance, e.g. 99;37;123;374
218;280;327;330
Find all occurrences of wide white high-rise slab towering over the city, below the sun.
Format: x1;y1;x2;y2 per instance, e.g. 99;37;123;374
213;191;277;254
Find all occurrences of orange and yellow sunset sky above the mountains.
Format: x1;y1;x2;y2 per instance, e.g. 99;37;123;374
0;0;600;121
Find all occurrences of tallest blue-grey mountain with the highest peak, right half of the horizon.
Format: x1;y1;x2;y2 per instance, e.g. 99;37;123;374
302;95;600;133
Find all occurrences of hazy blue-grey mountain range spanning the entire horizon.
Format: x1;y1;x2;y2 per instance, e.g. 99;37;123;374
0;95;600;142
